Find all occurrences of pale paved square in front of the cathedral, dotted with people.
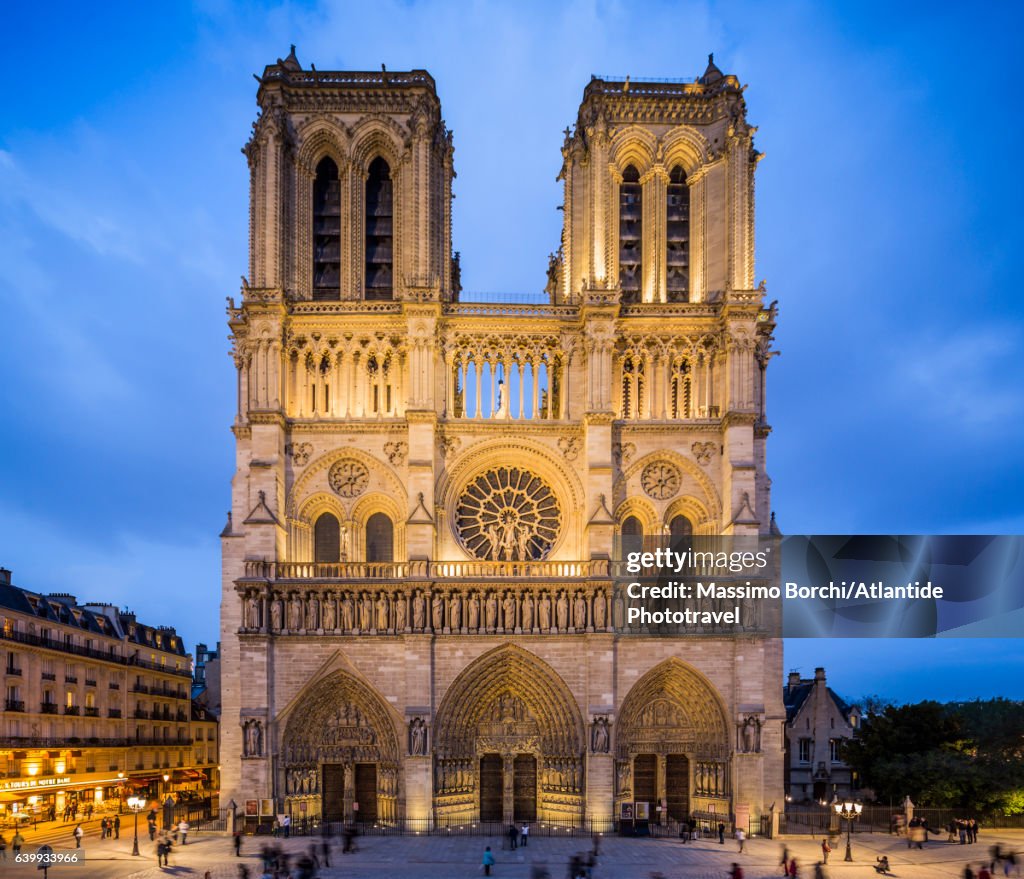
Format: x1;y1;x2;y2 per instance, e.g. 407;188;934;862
0;831;1024;879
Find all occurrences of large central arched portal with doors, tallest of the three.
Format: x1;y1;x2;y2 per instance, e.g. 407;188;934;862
434;644;585;823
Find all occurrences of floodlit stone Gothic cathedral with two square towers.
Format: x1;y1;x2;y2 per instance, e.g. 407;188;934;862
221;48;784;827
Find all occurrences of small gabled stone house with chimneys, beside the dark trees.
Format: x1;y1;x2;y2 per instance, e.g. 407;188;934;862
782;668;862;802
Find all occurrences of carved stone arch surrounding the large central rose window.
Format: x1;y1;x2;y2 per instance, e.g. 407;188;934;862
435;435;584;560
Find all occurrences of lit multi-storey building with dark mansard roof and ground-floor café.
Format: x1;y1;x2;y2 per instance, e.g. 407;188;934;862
0;569;216;814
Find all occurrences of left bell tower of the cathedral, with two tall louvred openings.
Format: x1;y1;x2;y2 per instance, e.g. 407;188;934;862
244;46;458;301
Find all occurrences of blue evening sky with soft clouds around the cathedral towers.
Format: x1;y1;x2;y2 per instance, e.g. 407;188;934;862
0;0;1024;699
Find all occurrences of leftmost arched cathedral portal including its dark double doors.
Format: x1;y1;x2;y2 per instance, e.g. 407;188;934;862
274;671;400;823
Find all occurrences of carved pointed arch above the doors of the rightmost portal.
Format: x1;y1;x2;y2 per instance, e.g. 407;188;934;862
615;657;730;760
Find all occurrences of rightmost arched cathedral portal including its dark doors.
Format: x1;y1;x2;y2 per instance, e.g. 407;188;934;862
615;659;731;821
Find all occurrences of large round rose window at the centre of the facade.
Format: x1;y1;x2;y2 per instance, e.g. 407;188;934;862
456;467;561;561
